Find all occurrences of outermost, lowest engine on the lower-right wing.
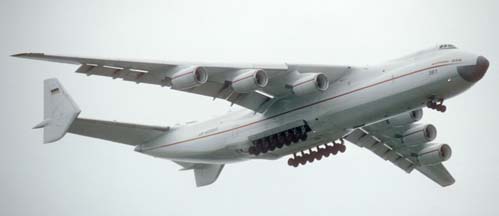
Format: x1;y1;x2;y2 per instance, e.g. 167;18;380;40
418;144;452;166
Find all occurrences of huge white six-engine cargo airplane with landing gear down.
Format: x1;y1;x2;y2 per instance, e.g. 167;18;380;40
13;44;489;187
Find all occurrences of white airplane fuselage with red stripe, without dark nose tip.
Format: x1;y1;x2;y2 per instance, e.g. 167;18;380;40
136;49;479;164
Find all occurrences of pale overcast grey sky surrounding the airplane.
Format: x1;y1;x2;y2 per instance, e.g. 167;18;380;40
0;0;499;216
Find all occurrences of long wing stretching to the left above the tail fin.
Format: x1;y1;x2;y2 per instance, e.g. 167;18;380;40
13;53;352;112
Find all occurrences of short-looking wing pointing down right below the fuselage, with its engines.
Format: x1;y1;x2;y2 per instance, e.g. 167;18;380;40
345;110;455;186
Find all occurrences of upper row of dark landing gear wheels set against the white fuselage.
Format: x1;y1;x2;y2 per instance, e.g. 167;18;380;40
248;124;311;156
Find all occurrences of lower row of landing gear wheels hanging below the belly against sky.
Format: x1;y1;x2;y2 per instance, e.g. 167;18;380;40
288;139;346;167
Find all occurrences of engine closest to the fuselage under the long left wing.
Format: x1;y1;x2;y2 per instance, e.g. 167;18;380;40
291;73;329;96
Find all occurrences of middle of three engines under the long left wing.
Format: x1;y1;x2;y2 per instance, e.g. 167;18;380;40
232;69;269;93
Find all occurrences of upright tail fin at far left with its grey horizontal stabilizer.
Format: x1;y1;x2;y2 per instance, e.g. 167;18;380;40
34;79;169;145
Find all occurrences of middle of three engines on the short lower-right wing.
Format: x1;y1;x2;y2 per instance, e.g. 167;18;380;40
402;124;437;145
